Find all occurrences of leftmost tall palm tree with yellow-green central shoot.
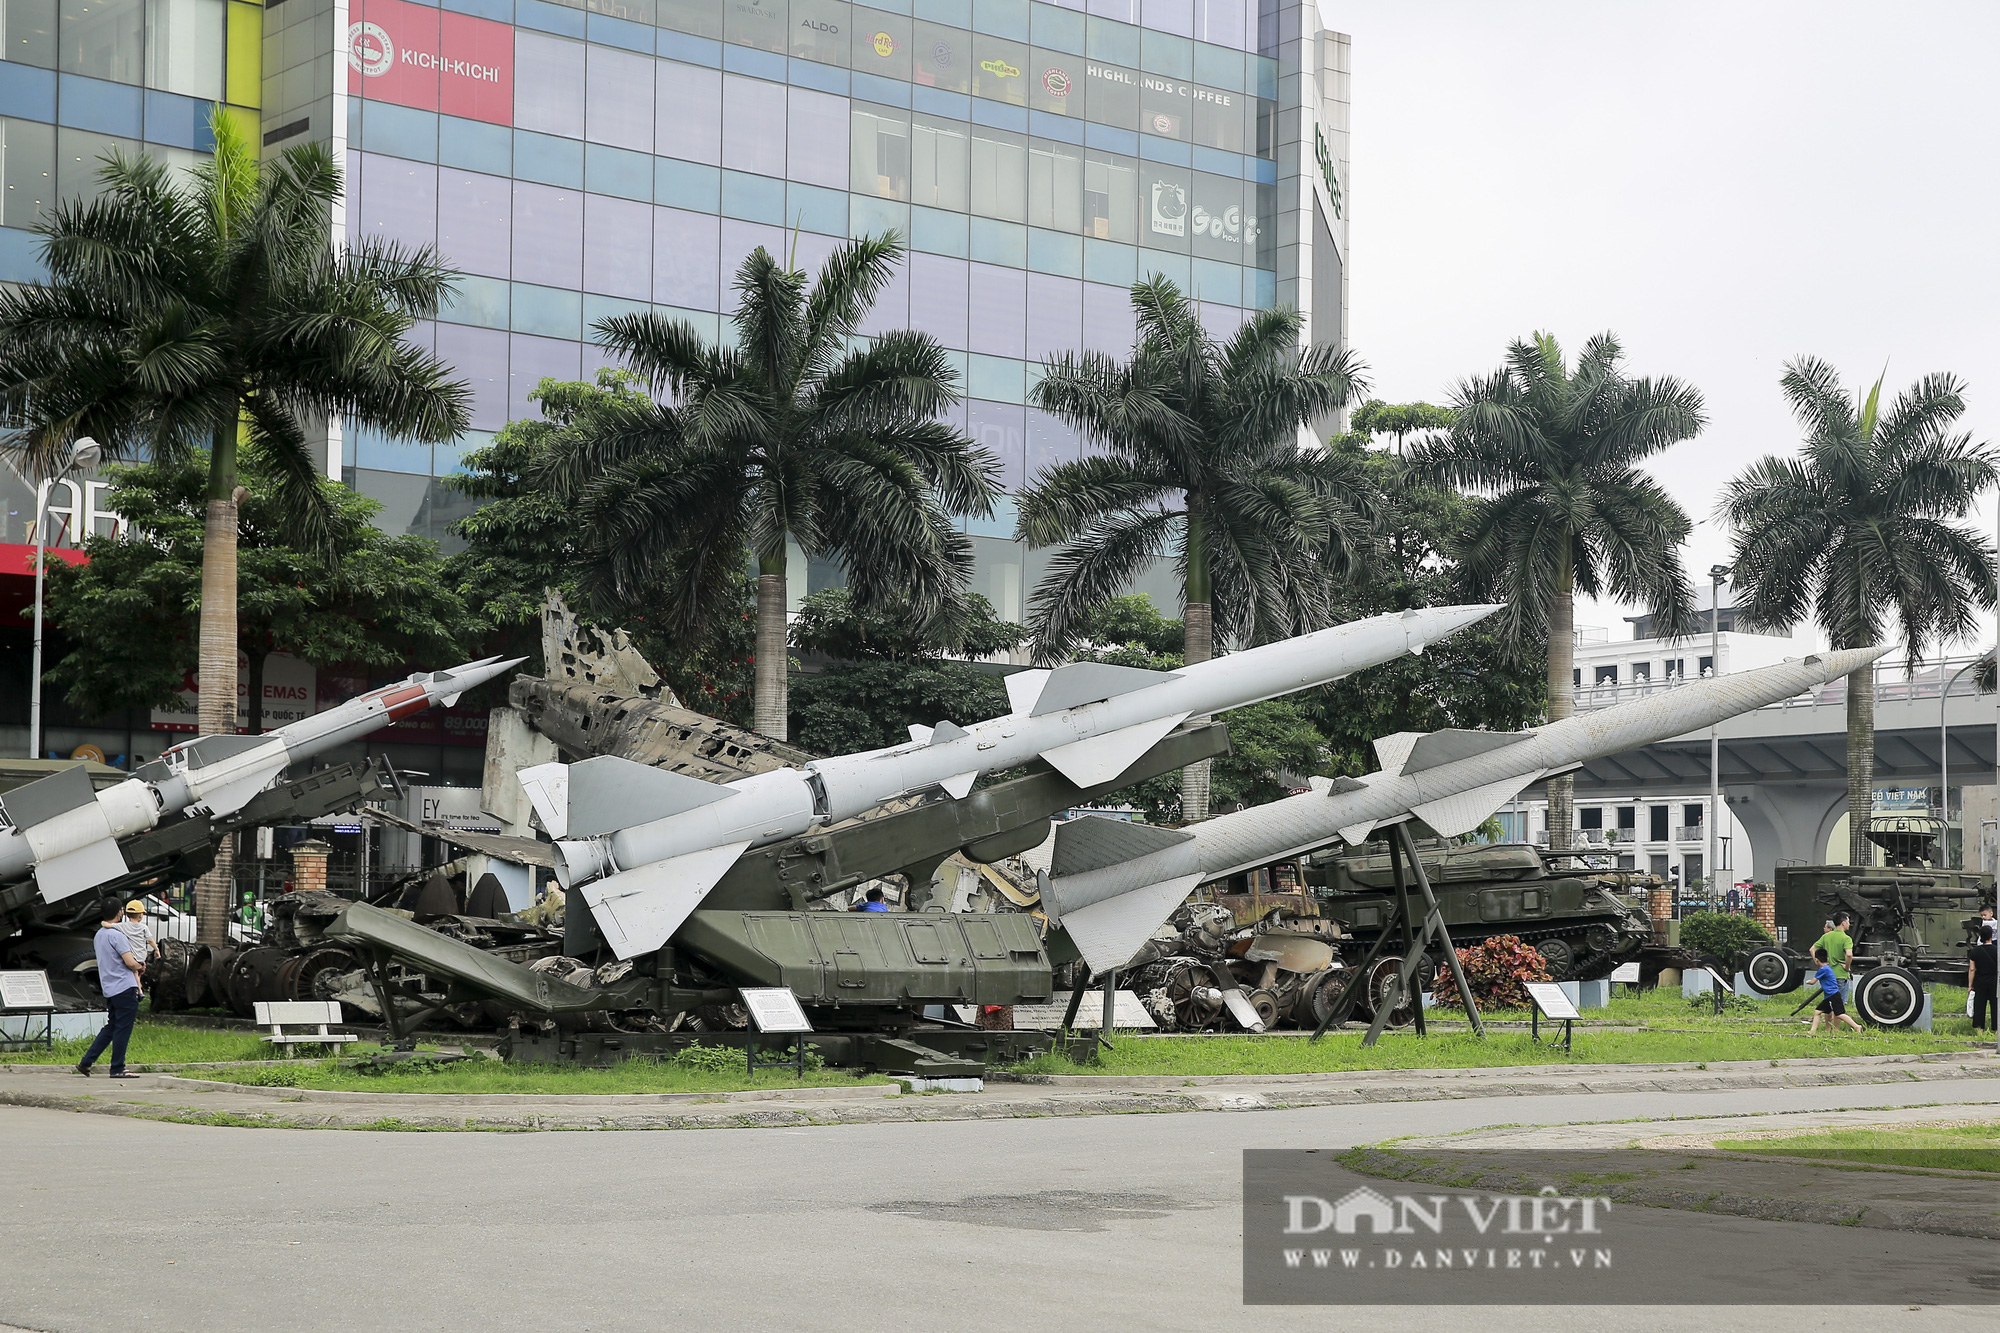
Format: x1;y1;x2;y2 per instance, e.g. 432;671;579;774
0;110;470;943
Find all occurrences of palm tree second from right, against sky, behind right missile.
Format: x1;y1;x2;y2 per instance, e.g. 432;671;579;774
1414;332;1704;851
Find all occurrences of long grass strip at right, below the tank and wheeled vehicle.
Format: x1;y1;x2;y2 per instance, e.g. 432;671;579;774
1016;1019;1966;1075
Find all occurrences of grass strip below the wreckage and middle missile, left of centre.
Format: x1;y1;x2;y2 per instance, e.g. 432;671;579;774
198;1051;892;1095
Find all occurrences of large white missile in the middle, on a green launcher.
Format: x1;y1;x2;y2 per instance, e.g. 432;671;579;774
520;606;1498;959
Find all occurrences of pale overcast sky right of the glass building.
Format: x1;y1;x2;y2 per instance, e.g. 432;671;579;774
1320;0;2000;642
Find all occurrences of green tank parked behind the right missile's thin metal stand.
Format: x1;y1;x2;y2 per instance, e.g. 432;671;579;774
1304;839;1652;981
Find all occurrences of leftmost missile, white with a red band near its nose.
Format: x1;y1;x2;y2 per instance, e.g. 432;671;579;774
0;656;522;903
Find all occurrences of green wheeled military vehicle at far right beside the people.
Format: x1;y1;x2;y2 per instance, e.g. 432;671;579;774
1736;865;1994;1027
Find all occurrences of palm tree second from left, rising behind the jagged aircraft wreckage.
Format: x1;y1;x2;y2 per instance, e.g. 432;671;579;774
560;232;1000;741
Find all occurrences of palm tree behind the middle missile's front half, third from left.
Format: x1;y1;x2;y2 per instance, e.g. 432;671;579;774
1016;274;1374;821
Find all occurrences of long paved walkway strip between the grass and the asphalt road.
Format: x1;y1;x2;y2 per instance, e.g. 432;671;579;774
0;1051;2000;1131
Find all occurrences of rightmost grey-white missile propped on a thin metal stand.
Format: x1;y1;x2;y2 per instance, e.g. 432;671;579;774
1042;648;1890;973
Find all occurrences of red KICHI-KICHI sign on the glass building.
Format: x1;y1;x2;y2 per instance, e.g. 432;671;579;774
348;0;514;124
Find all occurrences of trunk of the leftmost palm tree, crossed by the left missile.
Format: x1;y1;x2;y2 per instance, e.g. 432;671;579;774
194;414;238;945
